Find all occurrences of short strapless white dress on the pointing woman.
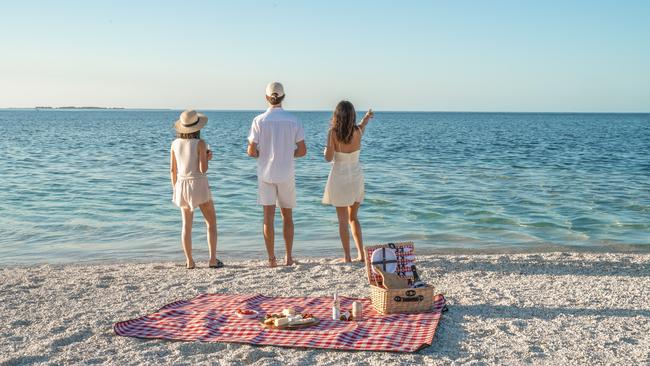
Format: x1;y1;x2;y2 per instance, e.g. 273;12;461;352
323;150;365;207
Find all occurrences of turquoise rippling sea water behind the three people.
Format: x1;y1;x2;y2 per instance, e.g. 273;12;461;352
0;110;650;264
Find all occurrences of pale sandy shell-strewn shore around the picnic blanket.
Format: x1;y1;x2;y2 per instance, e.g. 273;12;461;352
0;253;650;365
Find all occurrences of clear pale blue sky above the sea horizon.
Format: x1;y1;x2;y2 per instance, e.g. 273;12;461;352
0;0;650;112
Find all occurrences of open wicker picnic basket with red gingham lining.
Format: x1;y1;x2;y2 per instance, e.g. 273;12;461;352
365;242;433;314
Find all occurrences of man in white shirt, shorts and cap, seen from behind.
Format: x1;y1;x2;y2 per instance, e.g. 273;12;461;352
248;82;307;267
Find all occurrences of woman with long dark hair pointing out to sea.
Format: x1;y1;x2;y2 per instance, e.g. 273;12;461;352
323;100;374;262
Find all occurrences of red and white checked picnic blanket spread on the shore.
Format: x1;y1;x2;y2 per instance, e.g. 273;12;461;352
113;294;445;352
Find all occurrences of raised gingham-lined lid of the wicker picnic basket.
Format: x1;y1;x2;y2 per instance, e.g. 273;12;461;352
365;241;415;286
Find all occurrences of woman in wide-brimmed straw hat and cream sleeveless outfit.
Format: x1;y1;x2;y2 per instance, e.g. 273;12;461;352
169;110;223;269
